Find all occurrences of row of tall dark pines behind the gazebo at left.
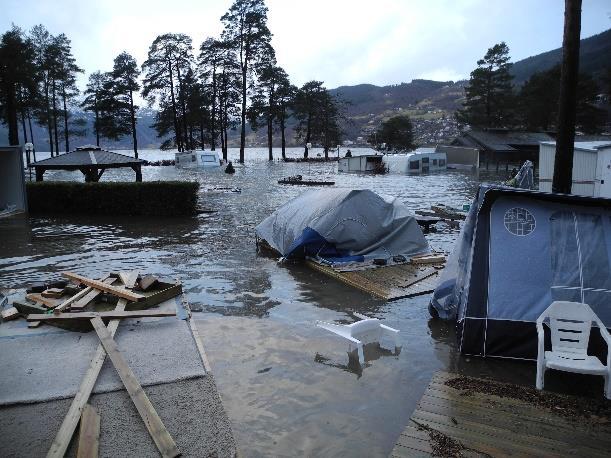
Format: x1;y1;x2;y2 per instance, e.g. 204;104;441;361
0;0;343;162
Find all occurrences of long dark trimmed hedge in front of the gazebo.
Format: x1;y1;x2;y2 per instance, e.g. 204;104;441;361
26;181;199;216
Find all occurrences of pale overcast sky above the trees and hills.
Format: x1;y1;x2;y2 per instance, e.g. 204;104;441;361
0;0;611;92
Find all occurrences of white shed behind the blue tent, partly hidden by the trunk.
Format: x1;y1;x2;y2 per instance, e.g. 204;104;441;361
539;141;611;198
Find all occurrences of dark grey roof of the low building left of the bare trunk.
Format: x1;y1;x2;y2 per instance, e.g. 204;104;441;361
452;129;553;152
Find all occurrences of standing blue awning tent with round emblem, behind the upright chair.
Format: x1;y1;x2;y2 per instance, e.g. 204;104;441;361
430;185;611;359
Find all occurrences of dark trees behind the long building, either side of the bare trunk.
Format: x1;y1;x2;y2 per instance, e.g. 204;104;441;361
457;43;609;133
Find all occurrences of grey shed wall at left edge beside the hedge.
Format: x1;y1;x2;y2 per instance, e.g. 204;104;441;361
0;146;28;217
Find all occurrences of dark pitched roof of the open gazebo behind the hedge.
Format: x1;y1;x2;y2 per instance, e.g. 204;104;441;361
32;146;144;169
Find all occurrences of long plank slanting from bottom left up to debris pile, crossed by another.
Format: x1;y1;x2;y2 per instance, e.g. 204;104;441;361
47;299;127;458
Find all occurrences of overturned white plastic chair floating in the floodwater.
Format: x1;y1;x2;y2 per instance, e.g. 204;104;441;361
316;312;399;366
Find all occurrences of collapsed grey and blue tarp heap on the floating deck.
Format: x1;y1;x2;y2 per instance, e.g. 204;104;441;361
256;189;430;264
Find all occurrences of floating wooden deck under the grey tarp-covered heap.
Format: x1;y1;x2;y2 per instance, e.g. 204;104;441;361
307;260;441;301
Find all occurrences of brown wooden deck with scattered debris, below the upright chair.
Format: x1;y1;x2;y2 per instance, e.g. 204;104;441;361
391;372;611;457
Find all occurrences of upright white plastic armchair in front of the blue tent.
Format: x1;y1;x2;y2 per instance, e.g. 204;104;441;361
537;301;611;399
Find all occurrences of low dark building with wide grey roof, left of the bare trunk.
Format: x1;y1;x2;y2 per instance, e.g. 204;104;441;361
450;129;554;171
